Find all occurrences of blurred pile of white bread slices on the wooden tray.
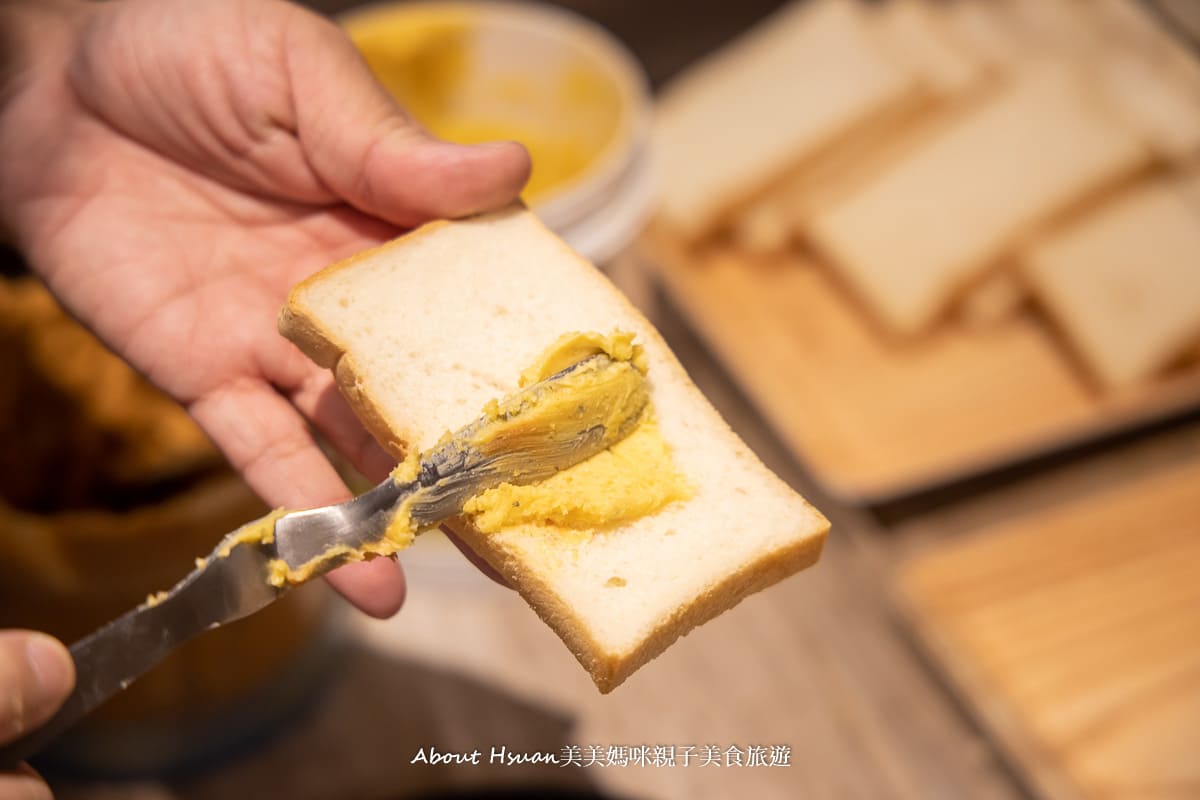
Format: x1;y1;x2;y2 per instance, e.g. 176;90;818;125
659;0;1200;392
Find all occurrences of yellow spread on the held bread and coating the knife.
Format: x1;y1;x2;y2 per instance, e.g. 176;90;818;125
224;332;691;587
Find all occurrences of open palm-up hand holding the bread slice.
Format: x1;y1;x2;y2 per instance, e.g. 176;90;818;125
0;0;529;616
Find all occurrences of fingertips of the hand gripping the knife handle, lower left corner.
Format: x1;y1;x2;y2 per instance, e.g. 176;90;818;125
0;631;74;800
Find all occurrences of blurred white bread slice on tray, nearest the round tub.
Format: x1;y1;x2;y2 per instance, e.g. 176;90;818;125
656;0;920;237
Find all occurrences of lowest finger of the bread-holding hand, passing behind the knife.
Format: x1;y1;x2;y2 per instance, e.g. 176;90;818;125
190;380;404;615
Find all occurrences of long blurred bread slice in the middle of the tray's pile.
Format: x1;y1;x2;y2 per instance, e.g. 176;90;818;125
808;65;1150;333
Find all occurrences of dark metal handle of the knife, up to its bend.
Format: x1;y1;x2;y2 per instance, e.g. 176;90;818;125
0;546;281;770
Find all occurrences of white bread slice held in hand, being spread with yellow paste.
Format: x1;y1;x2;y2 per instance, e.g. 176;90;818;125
280;207;828;692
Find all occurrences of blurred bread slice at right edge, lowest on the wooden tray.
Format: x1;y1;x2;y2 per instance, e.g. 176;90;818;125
1025;178;1200;386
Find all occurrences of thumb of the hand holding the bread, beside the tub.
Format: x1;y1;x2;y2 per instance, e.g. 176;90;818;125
288;12;530;227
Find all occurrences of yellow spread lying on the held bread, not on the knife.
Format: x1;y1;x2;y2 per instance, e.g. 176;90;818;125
463;332;691;534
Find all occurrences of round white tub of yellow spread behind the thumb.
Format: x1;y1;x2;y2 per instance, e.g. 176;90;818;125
341;1;655;264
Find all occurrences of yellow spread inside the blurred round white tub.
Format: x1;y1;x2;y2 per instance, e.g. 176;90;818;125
347;5;622;203
